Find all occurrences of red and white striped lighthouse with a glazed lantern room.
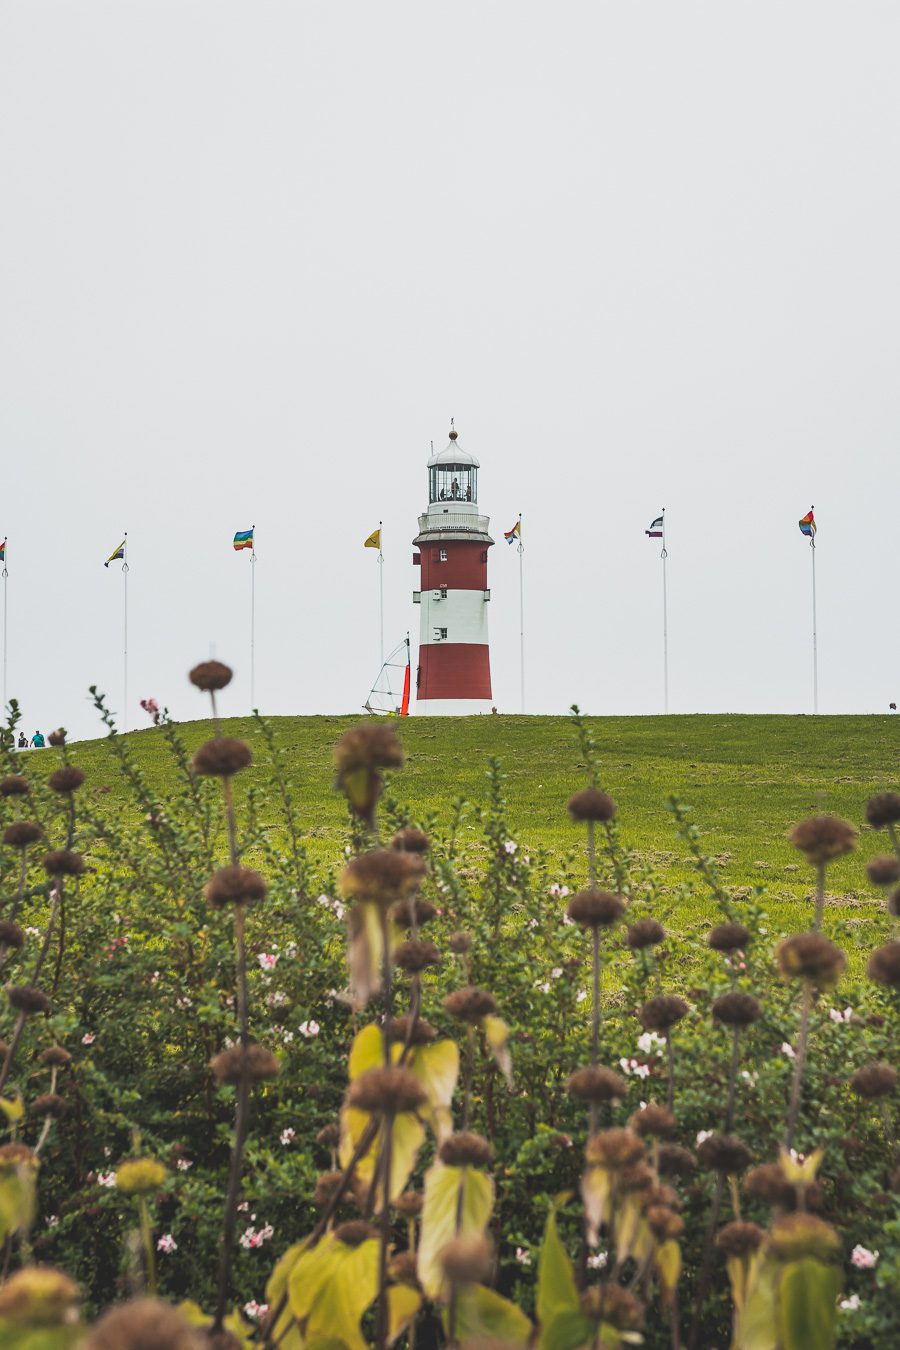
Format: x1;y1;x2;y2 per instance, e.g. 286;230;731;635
413;421;494;716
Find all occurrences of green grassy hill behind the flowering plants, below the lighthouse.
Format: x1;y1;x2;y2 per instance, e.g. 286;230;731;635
38;714;900;936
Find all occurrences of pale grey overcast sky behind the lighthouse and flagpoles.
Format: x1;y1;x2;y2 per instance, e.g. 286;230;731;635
0;0;900;734
